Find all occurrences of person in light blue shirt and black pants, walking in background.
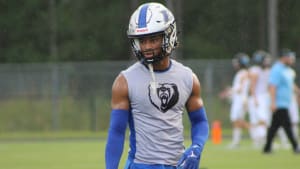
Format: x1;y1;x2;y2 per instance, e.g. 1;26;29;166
263;49;300;154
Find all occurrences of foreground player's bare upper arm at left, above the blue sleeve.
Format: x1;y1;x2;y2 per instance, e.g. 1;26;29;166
111;74;129;110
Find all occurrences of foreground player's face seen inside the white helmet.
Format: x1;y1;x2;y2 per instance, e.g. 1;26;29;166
139;35;163;58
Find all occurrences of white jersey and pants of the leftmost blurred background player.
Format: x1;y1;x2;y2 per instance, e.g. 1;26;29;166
230;69;249;121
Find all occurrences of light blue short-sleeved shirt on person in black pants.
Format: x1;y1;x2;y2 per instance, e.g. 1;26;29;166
269;61;294;108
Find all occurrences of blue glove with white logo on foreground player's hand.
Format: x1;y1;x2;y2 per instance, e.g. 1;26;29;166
177;145;202;169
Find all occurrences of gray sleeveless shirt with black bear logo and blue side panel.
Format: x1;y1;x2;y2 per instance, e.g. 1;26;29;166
122;60;193;165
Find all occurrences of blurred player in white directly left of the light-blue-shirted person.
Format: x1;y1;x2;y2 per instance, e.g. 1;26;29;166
249;50;271;148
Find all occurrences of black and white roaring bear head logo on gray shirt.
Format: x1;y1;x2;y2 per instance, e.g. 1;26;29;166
148;83;179;113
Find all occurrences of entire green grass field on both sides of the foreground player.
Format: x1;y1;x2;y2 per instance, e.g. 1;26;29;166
0;133;300;169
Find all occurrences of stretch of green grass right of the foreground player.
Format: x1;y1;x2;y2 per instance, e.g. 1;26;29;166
201;141;299;169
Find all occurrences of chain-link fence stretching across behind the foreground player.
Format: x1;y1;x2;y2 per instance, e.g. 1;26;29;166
0;60;300;132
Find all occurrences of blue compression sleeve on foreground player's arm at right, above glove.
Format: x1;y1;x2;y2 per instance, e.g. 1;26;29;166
188;107;209;149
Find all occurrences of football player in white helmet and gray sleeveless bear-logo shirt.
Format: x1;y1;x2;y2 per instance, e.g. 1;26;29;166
105;3;209;169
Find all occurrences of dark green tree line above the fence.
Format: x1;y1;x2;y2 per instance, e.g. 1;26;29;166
0;0;300;63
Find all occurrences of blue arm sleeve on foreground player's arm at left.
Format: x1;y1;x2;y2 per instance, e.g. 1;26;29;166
105;109;129;169
